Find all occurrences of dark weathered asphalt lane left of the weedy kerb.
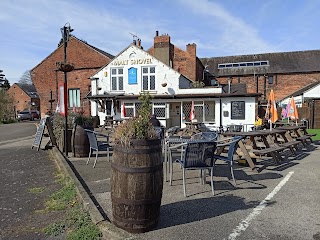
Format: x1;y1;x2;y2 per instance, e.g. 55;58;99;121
0;122;65;240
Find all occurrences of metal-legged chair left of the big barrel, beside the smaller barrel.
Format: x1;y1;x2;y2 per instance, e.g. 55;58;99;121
85;129;111;167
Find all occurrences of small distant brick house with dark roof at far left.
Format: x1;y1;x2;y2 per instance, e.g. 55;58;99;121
8;83;40;113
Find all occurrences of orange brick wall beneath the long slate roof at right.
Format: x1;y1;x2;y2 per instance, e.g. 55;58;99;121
217;73;320;100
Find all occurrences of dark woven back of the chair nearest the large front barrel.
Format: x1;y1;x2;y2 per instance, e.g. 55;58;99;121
183;141;216;168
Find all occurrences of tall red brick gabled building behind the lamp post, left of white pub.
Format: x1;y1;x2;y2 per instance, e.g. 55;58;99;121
31;35;114;117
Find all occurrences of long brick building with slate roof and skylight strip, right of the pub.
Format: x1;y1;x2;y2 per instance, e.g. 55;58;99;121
201;50;320;106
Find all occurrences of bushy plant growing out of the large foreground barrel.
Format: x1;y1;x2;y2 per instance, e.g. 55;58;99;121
113;92;158;146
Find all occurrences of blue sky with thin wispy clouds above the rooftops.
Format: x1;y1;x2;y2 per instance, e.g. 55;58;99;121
0;0;320;84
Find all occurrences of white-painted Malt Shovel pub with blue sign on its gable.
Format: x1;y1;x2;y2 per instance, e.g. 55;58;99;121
88;39;261;128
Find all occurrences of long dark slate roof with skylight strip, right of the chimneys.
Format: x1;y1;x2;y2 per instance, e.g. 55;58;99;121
200;50;320;76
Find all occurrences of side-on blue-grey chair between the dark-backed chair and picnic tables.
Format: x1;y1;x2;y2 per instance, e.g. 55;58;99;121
214;136;243;185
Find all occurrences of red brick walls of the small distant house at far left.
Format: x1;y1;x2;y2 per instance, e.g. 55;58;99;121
7;83;40;113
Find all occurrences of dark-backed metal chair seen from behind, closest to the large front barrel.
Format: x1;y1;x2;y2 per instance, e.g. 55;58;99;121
170;141;216;197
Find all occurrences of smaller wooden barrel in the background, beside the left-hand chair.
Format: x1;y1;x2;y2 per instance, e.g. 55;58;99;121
73;125;93;158
